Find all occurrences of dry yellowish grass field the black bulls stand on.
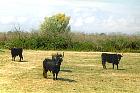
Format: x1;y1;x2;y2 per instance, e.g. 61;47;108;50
0;50;140;93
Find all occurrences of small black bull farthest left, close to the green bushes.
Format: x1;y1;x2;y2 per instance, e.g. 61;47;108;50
11;48;23;61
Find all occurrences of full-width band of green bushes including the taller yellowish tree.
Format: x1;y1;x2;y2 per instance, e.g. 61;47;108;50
0;13;140;52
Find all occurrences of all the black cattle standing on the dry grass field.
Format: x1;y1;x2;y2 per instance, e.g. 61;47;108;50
11;48;123;80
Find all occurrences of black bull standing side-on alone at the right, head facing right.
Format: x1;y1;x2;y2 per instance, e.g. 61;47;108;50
101;53;122;69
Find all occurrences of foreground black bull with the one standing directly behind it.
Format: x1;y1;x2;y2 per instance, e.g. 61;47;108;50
43;54;64;80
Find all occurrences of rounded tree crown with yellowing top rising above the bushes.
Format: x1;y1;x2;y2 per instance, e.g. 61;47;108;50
40;13;70;34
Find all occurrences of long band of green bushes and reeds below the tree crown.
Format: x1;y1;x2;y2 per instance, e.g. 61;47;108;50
0;33;140;52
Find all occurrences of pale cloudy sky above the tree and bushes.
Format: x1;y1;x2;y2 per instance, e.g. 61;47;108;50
0;0;140;34
